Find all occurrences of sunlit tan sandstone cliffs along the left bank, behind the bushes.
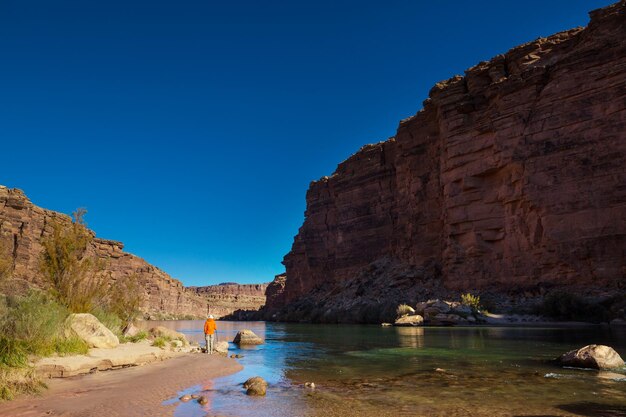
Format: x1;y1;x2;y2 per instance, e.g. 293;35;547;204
0;186;265;318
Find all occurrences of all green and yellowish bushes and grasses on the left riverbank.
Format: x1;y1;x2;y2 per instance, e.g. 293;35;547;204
0;210;147;400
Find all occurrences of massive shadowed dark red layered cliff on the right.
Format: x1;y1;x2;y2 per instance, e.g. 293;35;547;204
267;1;626;316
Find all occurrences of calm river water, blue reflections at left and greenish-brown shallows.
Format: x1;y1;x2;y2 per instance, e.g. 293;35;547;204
160;321;626;417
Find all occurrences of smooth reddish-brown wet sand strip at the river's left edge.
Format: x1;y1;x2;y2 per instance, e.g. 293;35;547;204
0;353;243;417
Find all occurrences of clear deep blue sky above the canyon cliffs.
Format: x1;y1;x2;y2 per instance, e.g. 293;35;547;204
0;0;609;285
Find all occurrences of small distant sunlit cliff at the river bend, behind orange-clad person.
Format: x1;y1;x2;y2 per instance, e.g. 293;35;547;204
188;283;268;317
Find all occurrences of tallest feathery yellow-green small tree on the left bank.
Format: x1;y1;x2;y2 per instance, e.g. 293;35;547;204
40;209;106;313
